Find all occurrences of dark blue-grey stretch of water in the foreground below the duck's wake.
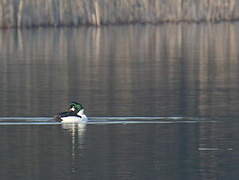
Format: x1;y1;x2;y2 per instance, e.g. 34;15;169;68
0;121;239;180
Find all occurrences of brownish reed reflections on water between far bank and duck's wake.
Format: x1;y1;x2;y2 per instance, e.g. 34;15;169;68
0;24;239;117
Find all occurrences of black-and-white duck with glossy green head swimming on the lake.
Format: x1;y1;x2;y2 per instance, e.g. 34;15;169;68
54;101;88;123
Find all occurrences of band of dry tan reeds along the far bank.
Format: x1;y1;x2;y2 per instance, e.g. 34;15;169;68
0;0;239;28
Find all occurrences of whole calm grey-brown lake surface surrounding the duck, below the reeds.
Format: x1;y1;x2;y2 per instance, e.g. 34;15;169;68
0;24;239;180
